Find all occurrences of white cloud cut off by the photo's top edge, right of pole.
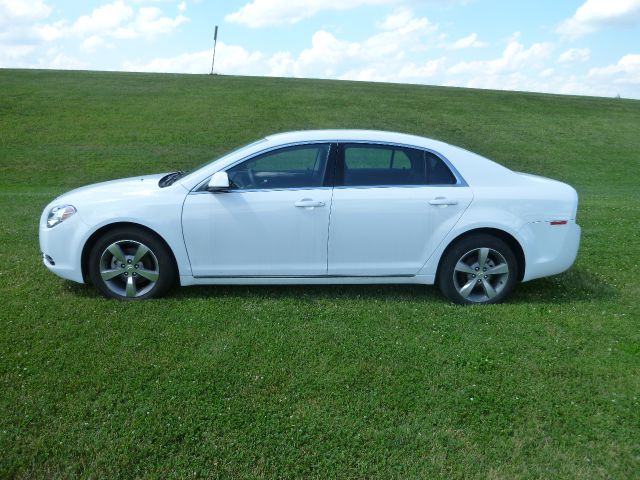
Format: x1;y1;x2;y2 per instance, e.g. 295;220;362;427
225;0;466;29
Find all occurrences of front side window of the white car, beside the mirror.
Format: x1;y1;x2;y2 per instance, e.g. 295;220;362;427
227;144;330;190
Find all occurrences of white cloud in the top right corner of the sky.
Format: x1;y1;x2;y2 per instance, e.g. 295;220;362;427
557;0;640;38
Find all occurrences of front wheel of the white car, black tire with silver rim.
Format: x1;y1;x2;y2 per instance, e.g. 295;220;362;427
89;227;177;300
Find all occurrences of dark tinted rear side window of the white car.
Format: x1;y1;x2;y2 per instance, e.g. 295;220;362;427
340;144;456;187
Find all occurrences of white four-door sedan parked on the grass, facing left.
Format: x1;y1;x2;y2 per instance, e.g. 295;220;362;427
39;130;580;304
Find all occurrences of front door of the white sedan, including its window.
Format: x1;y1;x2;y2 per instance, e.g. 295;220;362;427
182;144;332;277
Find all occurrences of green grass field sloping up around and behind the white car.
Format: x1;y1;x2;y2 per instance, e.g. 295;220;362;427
0;70;640;479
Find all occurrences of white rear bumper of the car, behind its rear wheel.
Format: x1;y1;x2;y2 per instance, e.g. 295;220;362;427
518;220;581;282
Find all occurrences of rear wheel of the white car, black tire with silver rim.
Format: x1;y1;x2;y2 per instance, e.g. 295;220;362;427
437;234;519;305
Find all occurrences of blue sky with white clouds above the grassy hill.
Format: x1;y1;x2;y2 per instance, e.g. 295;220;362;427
0;0;640;99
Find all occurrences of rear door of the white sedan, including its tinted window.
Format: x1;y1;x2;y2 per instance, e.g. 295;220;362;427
328;143;473;276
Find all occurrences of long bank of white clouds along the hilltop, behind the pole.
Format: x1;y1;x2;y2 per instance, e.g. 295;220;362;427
134;16;634;95
